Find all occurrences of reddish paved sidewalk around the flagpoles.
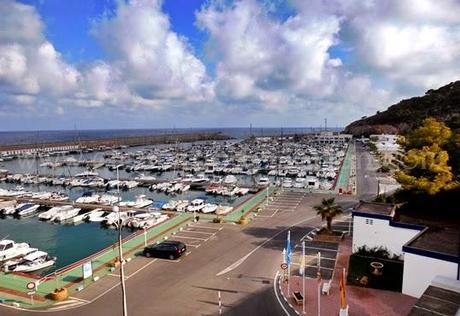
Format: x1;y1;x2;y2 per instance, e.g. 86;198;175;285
281;237;417;316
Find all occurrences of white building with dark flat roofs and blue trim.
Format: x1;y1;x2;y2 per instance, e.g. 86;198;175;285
353;202;460;297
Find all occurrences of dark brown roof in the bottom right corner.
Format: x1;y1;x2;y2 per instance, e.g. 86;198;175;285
408;278;460;316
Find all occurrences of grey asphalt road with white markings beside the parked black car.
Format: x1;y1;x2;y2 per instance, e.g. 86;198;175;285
0;191;356;316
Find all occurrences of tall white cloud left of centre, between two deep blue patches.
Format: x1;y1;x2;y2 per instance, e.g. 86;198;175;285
93;0;212;101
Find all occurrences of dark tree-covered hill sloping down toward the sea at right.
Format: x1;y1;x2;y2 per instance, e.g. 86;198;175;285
345;81;460;136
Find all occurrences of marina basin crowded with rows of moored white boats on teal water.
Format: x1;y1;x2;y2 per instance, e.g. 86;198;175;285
0;133;349;286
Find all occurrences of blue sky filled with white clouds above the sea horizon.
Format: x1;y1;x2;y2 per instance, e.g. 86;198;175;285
0;0;460;130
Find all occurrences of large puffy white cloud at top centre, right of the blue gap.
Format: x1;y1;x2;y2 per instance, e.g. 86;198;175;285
197;0;340;106
